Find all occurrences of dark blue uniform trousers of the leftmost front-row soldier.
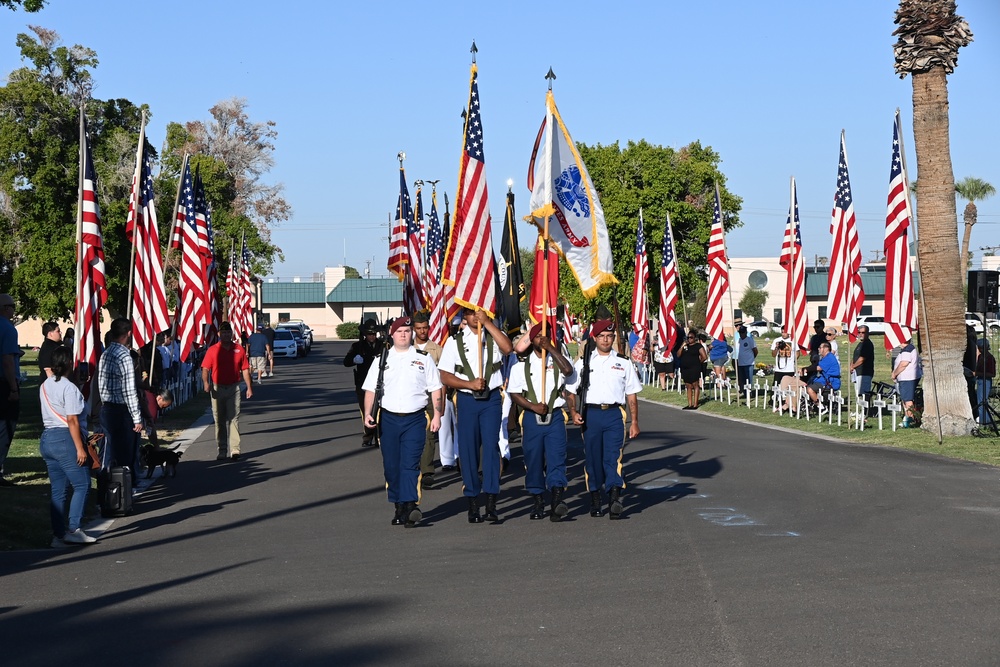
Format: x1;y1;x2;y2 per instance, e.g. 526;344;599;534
379;410;427;503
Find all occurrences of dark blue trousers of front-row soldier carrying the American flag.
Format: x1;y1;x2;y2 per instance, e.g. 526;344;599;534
456;389;501;498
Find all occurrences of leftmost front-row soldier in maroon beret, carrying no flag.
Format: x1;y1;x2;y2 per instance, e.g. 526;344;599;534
362;316;444;528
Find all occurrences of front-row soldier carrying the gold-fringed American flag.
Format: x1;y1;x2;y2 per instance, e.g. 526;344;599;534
440;308;514;523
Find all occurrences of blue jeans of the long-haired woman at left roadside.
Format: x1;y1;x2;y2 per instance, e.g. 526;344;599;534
39;428;90;538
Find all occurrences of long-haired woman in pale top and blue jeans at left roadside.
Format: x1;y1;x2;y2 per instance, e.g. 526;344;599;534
38;347;97;549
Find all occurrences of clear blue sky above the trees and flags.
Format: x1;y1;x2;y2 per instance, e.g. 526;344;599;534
0;0;1000;278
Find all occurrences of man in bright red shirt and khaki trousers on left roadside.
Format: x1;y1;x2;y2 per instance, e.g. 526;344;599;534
201;322;253;461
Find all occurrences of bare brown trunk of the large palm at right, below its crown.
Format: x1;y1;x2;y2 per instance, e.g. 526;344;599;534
912;66;975;435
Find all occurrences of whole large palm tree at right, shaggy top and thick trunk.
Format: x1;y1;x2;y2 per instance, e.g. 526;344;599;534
893;0;975;435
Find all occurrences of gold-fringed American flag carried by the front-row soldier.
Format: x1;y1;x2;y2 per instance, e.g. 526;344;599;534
443;63;496;317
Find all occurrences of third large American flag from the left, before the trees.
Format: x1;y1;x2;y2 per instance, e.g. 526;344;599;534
177;163;208;361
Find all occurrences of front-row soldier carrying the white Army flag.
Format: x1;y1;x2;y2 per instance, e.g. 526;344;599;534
507;323;576;521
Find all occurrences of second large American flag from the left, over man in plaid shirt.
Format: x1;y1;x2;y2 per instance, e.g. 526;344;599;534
125;133;170;348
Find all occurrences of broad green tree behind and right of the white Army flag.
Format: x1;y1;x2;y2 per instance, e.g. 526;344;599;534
572;140;742;322
